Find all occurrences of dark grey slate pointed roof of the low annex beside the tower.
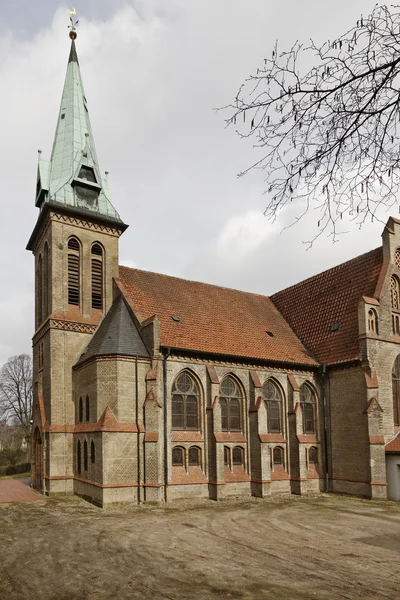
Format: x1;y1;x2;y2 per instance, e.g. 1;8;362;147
77;296;149;364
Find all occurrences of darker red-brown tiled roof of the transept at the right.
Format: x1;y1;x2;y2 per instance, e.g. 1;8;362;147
271;247;383;365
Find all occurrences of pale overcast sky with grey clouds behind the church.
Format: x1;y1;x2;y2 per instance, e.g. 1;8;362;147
0;0;388;364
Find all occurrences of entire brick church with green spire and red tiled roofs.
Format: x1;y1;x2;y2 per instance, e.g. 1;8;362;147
27;30;400;506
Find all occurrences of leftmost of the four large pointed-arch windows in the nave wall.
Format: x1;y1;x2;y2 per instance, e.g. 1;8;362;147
172;371;200;430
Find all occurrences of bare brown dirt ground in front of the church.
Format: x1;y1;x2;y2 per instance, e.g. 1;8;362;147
0;496;400;600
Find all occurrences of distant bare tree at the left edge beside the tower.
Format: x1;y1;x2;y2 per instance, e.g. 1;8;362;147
0;354;32;436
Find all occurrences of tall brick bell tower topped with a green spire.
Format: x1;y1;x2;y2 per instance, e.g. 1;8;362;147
27;27;127;494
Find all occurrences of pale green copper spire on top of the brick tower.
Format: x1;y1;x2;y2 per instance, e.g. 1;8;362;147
36;31;120;220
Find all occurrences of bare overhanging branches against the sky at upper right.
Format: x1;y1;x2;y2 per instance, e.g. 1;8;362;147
225;5;400;244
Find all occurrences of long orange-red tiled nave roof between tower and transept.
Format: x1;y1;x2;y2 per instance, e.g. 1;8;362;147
119;266;317;366
